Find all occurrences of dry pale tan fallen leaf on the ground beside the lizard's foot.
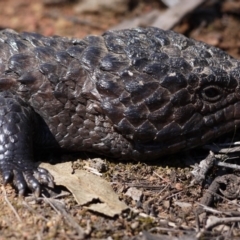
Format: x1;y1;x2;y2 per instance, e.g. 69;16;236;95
40;162;128;217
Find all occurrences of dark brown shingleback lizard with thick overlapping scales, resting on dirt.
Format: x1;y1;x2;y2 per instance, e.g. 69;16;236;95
0;28;240;194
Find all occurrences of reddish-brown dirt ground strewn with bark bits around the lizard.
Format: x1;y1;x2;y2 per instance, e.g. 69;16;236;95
0;0;240;240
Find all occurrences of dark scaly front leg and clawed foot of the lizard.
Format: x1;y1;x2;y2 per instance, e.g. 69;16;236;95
0;92;53;196
